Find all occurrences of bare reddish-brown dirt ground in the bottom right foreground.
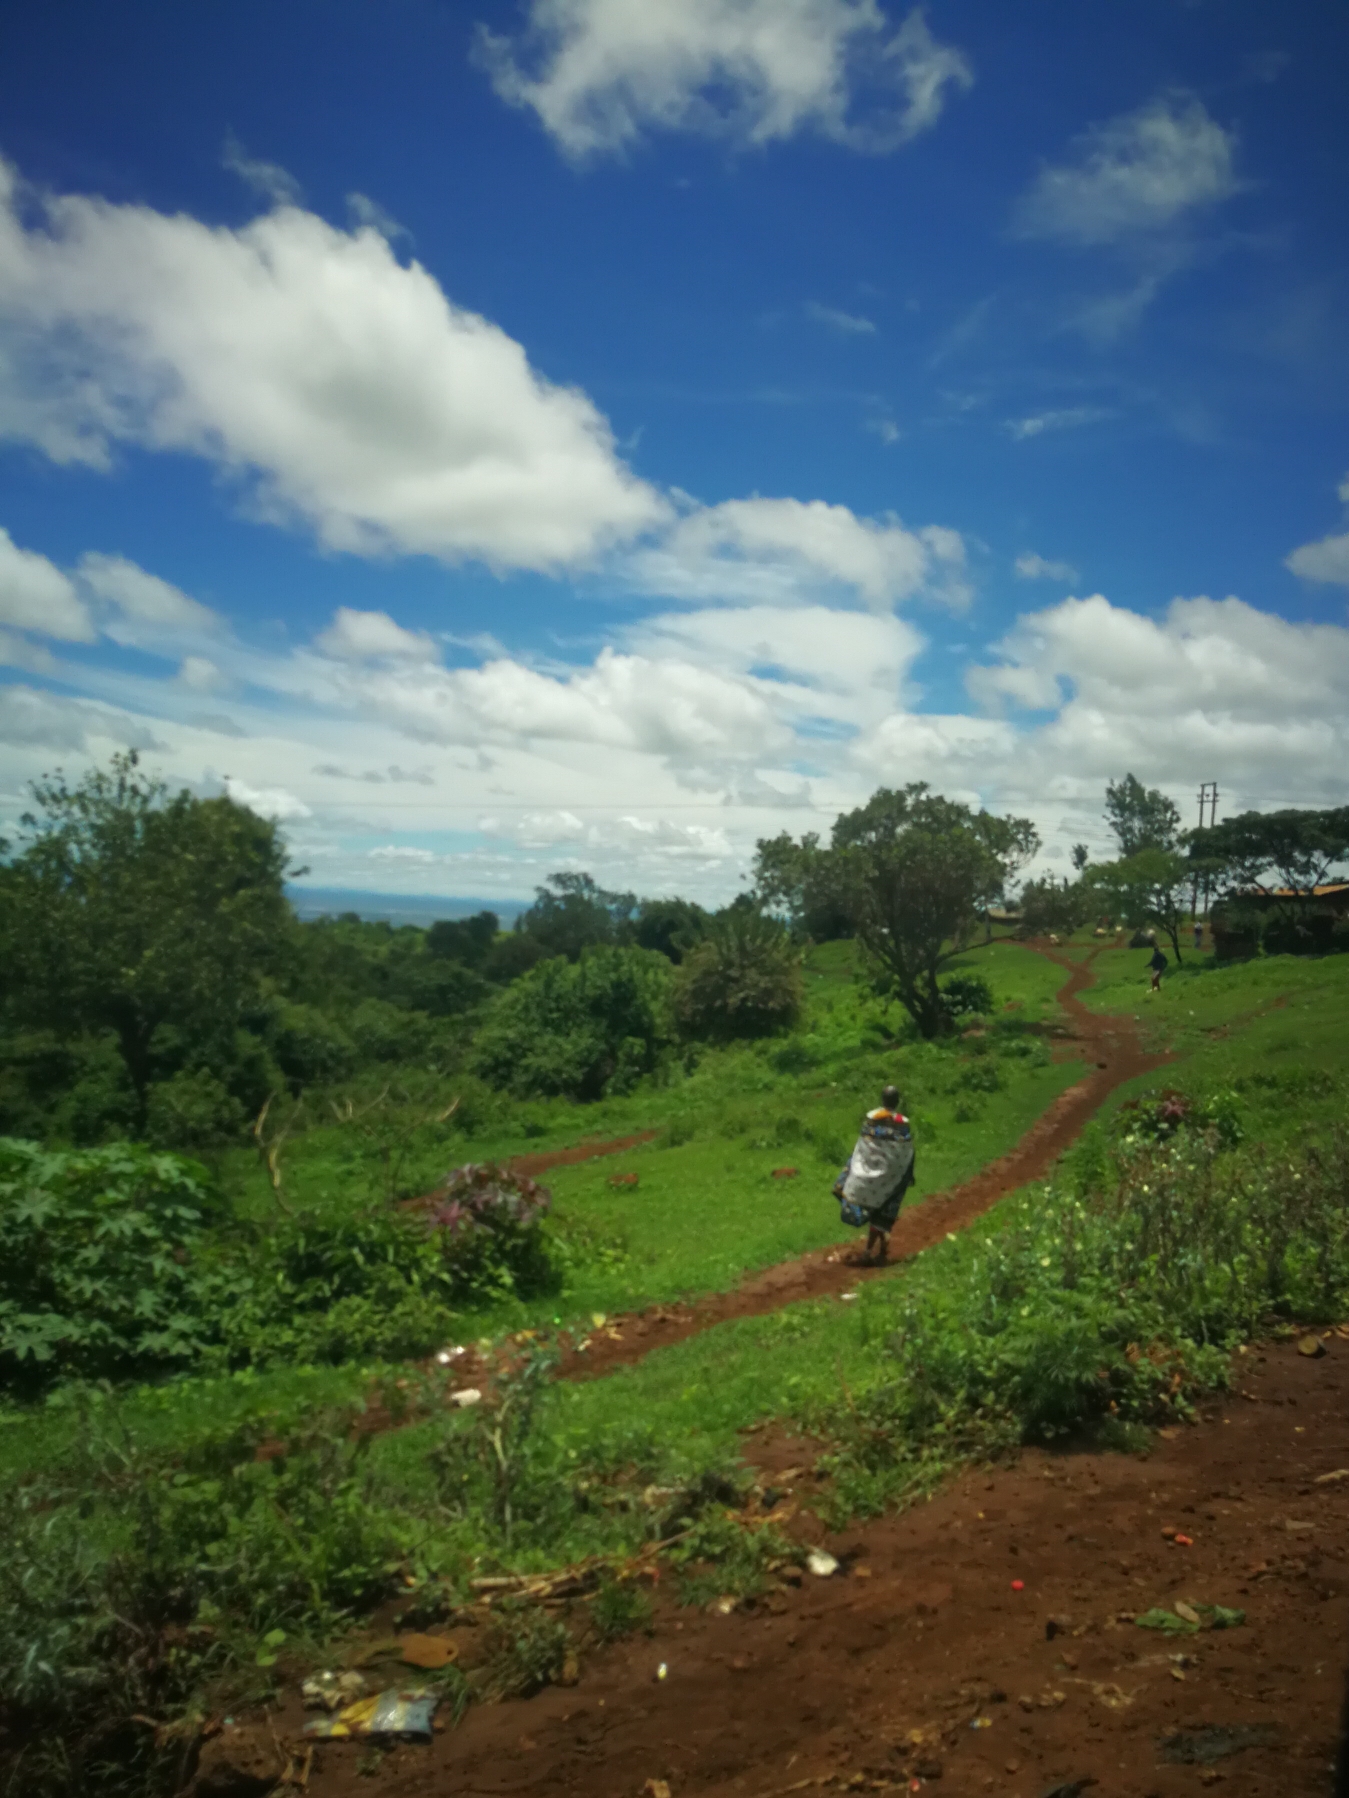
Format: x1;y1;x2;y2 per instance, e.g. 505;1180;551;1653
275;1331;1349;1798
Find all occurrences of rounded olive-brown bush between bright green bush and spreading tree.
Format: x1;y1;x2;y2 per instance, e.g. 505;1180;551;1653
675;906;802;1041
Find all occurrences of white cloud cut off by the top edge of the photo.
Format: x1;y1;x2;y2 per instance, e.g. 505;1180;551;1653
478;0;973;158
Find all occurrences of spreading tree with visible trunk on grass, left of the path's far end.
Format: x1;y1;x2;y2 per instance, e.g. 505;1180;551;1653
827;780;1040;1037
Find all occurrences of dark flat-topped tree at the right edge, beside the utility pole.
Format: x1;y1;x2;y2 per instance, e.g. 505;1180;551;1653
1189;806;1349;935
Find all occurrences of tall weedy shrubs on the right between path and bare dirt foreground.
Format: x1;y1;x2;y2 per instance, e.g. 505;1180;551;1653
813;1108;1349;1501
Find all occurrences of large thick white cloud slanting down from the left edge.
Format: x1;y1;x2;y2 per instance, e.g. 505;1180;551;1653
0;162;666;570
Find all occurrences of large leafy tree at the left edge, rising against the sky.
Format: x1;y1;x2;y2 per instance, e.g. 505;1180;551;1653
0;752;290;1120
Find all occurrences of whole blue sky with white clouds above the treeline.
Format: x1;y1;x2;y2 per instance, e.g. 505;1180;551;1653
0;0;1349;899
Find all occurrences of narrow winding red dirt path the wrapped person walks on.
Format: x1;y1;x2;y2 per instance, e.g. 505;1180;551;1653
559;942;1171;1379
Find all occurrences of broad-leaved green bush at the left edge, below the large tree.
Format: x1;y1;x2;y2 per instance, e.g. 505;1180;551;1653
0;1138;210;1390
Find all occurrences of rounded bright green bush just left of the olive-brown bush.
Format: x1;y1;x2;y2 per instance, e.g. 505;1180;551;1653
473;948;671;1099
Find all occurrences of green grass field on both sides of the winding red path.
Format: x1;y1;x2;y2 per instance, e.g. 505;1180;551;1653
0;939;1349;1791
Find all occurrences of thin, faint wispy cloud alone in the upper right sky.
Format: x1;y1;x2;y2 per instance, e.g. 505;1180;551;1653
1014;92;1236;245
